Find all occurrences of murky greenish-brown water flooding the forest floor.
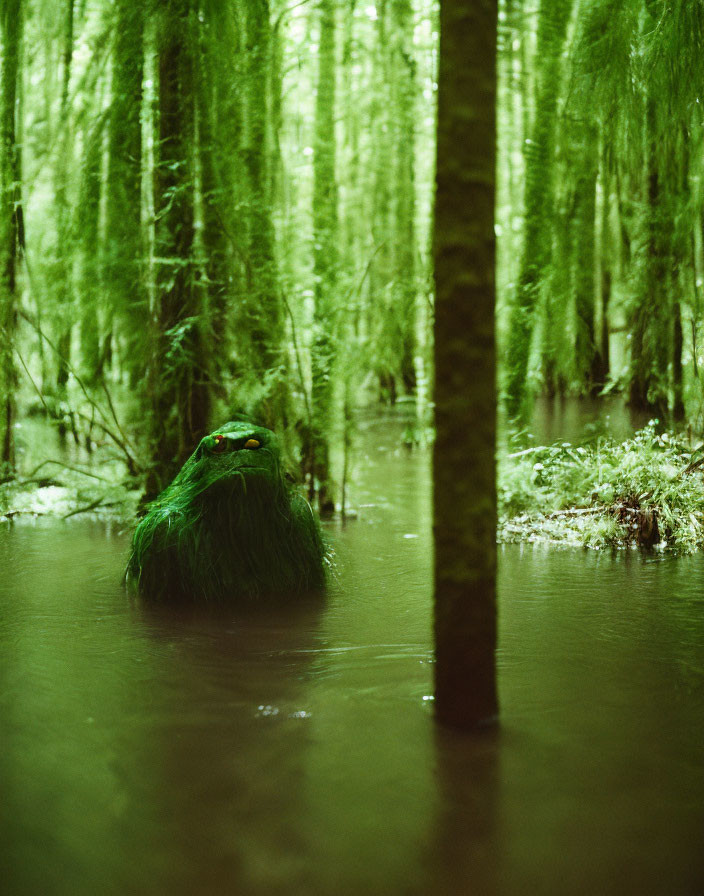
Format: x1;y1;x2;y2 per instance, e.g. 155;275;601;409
0;428;704;896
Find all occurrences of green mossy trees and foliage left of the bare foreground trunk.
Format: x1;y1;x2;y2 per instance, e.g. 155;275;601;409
0;0;437;508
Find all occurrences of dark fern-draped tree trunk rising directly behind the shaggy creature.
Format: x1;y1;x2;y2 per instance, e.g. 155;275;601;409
147;0;210;495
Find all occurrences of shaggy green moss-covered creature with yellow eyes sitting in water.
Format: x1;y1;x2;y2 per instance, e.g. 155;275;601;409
127;421;326;603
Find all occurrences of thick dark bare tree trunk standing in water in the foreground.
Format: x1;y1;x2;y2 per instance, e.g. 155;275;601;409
433;0;498;728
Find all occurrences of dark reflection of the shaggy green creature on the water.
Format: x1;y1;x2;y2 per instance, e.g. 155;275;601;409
128;606;320;894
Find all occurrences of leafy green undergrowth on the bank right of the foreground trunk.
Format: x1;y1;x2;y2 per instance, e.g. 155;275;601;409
499;421;704;552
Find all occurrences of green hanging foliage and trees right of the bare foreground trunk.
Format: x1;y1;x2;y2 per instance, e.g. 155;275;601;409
499;0;704;419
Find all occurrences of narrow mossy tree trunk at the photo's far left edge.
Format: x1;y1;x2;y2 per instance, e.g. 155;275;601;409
0;0;23;475
